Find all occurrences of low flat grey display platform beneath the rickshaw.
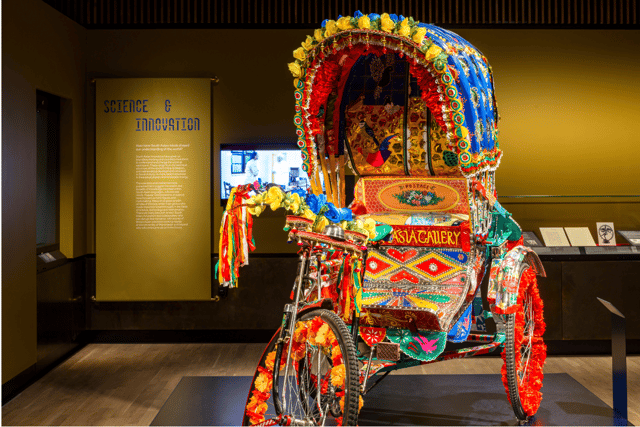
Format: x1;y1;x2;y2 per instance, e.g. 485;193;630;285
151;374;632;426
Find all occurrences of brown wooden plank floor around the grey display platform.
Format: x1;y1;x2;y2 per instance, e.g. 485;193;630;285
2;344;640;426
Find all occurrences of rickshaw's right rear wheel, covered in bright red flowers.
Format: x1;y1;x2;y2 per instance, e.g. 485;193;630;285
502;266;547;420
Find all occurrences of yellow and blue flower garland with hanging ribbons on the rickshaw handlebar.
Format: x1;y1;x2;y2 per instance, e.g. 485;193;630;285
216;184;376;288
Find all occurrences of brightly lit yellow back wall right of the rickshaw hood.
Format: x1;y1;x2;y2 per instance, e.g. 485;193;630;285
457;30;640;238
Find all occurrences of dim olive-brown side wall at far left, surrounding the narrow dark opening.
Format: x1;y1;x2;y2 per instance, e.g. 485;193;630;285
2;0;87;383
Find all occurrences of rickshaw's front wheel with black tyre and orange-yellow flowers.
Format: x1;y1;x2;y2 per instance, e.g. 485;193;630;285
242;309;361;425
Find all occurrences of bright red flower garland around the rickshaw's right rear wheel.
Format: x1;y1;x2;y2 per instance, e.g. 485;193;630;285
502;269;547;416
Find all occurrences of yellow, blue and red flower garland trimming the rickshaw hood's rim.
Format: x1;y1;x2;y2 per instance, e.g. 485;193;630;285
288;11;502;176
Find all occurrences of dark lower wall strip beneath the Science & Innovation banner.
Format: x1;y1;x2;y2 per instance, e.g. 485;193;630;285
87;256;298;332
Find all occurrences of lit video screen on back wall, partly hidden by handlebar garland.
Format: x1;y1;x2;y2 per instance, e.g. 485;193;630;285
220;146;309;199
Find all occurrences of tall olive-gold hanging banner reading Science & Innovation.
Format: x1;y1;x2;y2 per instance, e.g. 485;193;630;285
96;78;211;301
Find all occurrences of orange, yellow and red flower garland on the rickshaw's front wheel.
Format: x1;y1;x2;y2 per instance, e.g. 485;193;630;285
245;316;364;425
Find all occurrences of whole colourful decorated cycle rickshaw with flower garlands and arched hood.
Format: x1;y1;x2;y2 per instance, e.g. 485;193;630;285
218;12;546;425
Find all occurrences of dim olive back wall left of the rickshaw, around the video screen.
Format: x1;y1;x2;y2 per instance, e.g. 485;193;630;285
87;30;307;253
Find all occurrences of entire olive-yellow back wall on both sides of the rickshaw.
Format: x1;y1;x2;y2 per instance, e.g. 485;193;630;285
87;30;640;253
